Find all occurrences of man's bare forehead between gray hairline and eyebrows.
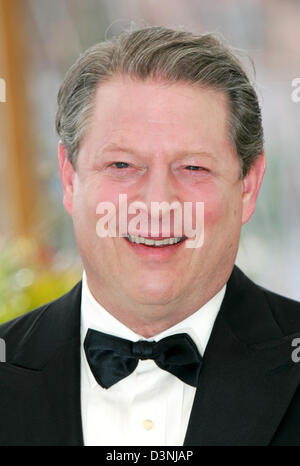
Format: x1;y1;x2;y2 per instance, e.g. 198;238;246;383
84;76;234;158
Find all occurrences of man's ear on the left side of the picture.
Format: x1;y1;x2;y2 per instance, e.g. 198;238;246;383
58;141;76;216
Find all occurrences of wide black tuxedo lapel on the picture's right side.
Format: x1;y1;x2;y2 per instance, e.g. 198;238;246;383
184;266;300;445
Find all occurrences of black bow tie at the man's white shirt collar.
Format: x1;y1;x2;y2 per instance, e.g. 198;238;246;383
84;328;202;388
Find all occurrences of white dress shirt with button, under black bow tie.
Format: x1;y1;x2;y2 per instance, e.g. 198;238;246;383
81;271;226;446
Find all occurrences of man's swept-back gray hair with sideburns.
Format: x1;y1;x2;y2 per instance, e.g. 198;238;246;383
56;26;264;178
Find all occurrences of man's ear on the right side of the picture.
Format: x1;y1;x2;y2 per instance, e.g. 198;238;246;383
242;153;266;224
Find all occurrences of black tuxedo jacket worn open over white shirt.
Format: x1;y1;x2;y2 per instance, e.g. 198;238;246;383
0;266;300;446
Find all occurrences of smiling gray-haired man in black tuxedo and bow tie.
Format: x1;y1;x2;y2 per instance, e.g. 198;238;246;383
0;27;300;446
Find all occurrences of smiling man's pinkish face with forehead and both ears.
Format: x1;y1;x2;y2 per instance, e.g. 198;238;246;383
60;77;264;324
